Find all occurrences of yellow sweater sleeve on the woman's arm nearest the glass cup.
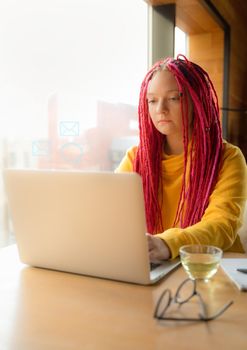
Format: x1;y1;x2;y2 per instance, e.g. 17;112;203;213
157;144;247;258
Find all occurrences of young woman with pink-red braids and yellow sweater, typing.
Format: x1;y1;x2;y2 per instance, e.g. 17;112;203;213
116;55;247;262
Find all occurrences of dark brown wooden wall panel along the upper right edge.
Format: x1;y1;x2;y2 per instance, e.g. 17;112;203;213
212;0;247;159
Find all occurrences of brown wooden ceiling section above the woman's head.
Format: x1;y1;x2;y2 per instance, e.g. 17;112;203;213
145;0;219;35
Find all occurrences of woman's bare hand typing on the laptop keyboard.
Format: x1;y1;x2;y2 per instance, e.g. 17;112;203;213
146;233;171;264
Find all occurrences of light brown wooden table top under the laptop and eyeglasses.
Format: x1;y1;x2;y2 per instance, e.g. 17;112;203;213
0;246;247;350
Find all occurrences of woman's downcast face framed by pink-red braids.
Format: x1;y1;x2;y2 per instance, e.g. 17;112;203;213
147;70;192;140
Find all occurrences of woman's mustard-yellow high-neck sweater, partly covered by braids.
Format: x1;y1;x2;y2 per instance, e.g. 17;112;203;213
116;142;247;258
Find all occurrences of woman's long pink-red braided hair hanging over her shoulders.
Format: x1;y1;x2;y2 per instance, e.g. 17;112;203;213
134;55;222;234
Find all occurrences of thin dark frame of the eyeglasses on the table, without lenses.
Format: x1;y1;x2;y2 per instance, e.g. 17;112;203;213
153;278;233;322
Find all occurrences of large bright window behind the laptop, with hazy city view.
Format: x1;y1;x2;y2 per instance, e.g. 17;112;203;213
0;0;147;246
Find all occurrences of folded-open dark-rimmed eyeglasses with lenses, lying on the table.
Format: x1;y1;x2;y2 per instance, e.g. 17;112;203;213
154;278;233;321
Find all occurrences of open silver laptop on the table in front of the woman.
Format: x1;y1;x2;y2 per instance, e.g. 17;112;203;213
4;169;179;284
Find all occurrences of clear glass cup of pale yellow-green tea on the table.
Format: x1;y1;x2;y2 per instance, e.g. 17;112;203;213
179;244;223;282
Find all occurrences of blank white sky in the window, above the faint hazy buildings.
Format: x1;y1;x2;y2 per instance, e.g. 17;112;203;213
0;0;147;138
